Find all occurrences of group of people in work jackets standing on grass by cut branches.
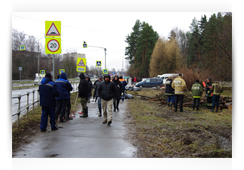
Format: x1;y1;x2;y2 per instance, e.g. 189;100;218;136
165;74;223;112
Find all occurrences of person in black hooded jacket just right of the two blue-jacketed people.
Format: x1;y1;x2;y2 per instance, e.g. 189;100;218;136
78;73;89;118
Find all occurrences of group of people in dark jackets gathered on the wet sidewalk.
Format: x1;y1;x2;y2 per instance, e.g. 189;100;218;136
39;73;127;132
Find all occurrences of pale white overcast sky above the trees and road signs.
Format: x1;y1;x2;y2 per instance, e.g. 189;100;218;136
12;12;217;70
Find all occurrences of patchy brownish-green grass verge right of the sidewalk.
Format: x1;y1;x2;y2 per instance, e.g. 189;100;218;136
128;89;232;158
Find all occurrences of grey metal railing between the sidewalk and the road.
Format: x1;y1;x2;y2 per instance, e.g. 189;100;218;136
12;82;79;126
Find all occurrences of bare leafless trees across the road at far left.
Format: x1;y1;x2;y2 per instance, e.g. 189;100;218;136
12;29;63;80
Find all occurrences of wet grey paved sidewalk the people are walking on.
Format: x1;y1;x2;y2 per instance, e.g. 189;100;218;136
13;99;136;158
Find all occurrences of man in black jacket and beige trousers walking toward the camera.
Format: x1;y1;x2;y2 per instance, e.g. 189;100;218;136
97;74;116;125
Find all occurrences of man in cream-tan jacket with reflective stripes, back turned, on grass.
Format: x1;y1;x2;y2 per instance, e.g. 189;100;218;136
171;74;186;112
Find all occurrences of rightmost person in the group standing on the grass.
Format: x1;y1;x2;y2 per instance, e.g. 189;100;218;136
210;81;223;112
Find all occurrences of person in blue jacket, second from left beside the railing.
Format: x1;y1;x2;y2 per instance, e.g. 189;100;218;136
55;73;73;123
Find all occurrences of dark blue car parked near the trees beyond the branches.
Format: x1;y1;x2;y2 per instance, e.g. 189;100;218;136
135;78;163;89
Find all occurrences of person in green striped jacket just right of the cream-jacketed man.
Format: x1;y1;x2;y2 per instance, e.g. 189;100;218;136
191;80;203;110
